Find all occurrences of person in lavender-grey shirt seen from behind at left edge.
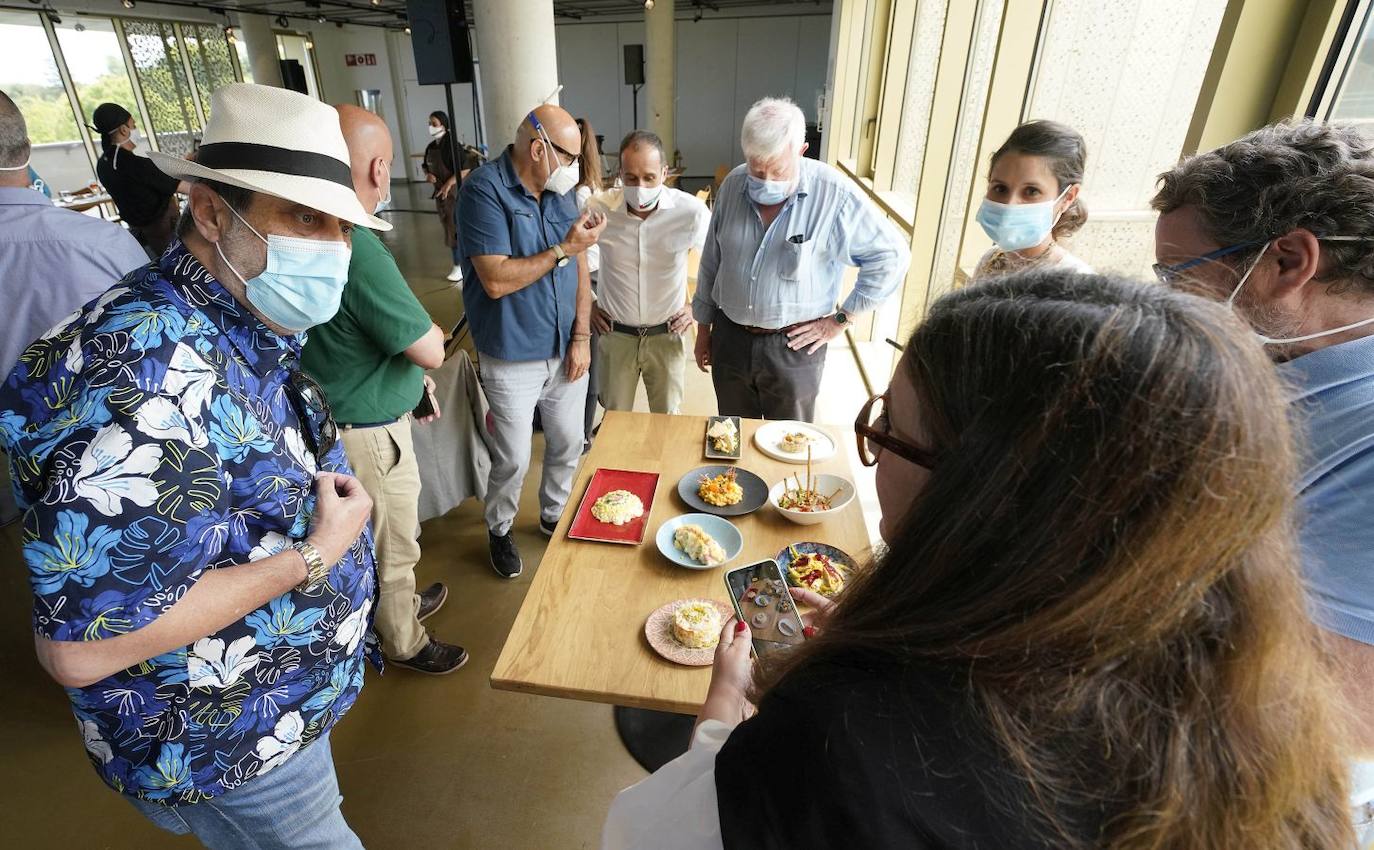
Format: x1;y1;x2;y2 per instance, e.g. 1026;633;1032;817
0;92;148;376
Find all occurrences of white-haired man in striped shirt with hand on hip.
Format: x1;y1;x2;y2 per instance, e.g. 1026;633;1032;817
692;97;911;422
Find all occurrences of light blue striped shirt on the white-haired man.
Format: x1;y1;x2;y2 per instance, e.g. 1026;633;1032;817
692;159;911;328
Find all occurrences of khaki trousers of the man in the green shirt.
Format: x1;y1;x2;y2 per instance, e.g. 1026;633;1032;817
339;415;429;661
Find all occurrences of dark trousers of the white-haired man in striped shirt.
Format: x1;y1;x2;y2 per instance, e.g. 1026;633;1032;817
710;312;829;422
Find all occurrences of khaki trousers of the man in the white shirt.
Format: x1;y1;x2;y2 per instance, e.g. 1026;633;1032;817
596;334;687;413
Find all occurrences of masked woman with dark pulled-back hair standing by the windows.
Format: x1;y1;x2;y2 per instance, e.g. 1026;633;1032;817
973;121;1092;282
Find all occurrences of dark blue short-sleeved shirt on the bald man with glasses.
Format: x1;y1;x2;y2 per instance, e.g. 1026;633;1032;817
458;147;577;360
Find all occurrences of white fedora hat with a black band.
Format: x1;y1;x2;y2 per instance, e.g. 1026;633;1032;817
148;82;392;231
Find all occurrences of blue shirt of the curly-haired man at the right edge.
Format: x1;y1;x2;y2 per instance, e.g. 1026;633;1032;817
1279;336;1374;644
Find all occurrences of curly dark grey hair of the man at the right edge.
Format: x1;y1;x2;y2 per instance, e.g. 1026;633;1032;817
1150;121;1374;294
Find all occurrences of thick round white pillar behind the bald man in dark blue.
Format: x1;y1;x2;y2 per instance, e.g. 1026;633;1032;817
473;0;558;150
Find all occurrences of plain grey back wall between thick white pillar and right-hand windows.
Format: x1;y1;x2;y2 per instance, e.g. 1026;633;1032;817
555;15;830;177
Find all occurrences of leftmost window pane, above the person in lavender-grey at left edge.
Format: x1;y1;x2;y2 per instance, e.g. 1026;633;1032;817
0;10;95;189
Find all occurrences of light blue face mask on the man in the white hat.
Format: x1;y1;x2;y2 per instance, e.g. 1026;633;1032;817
214;205;353;334
